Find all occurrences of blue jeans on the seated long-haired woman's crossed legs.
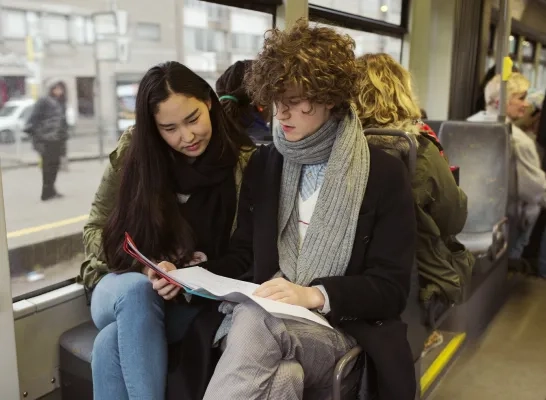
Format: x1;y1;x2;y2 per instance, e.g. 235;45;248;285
91;272;199;400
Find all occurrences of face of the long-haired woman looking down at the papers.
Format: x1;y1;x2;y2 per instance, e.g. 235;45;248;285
155;93;212;158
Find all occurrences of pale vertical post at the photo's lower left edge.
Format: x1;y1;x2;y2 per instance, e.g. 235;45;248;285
0;173;21;400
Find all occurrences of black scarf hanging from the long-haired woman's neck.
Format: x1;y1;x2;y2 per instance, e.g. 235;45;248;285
171;132;237;259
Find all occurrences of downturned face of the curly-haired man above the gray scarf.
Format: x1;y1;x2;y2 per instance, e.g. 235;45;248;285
275;90;334;142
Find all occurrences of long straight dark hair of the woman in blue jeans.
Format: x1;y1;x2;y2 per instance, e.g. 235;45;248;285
102;61;253;273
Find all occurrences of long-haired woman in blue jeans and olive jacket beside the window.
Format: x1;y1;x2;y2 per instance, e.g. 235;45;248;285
80;62;254;400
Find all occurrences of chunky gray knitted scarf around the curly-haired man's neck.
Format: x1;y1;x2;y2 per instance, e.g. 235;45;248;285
273;109;370;286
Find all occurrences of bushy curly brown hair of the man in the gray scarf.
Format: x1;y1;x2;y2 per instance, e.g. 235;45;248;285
245;18;360;116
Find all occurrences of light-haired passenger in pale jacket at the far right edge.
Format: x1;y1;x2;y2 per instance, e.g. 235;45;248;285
468;72;546;262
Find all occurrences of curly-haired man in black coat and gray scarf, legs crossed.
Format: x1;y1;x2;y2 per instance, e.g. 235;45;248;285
200;20;416;400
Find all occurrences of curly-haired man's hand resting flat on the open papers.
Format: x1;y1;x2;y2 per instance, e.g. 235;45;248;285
254;278;325;310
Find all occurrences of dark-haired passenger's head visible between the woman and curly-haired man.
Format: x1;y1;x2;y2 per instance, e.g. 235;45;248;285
216;60;271;140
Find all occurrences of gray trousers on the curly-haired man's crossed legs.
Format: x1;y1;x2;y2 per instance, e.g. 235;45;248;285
204;301;356;400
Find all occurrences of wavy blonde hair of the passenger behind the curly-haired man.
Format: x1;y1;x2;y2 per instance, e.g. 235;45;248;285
356;53;421;128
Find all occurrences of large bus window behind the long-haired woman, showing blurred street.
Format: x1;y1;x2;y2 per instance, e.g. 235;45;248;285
0;0;273;297
